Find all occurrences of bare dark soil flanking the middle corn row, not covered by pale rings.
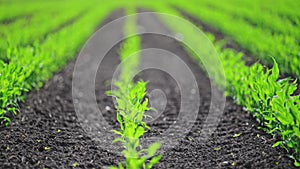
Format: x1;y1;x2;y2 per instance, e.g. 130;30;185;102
0;11;294;168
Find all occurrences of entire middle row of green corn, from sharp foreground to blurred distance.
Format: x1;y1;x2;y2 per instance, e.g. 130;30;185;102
107;7;162;169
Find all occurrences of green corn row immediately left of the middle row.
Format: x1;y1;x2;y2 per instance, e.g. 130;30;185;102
0;1;122;125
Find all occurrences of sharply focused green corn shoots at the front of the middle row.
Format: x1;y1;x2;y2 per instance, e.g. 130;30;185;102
111;81;162;169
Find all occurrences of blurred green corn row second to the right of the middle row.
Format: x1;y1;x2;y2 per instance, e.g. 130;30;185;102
171;1;300;78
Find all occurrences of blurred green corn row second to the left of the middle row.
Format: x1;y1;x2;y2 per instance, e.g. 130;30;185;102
0;2;92;60
